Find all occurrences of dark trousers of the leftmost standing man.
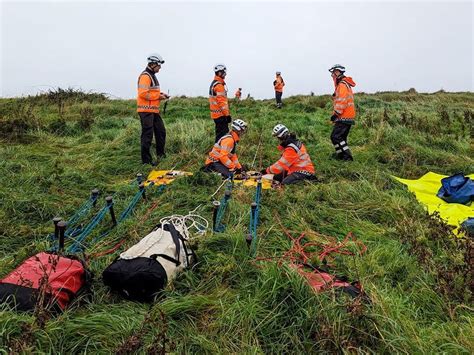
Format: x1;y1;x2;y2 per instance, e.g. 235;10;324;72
138;112;166;164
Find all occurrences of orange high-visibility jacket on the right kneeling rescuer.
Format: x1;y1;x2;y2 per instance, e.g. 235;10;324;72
267;141;314;175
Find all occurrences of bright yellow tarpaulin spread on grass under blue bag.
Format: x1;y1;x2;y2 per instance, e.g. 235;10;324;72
394;172;474;234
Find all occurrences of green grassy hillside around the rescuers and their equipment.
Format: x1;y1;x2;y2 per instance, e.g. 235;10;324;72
0;91;474;354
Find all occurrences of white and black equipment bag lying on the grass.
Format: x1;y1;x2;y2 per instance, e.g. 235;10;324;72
102;222;195;302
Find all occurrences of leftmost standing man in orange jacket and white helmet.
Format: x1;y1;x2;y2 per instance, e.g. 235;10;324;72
137;54;169;165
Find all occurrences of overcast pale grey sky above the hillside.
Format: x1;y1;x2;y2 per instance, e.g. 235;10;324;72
0;0;473;98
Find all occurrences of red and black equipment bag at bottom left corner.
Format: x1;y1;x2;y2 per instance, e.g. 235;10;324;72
0;252;91;312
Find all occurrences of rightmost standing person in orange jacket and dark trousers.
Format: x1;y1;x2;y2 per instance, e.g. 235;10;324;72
329;64;356;161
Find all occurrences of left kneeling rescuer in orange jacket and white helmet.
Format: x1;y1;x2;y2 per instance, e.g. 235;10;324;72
201;119;247;178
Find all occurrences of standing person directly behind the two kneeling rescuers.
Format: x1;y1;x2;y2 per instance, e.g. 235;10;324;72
209;64;232;142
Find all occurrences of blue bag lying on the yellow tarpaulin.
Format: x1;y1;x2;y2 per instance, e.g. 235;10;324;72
436;174;474;205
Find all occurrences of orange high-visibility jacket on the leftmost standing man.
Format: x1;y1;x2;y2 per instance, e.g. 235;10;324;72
137;67;160;113
